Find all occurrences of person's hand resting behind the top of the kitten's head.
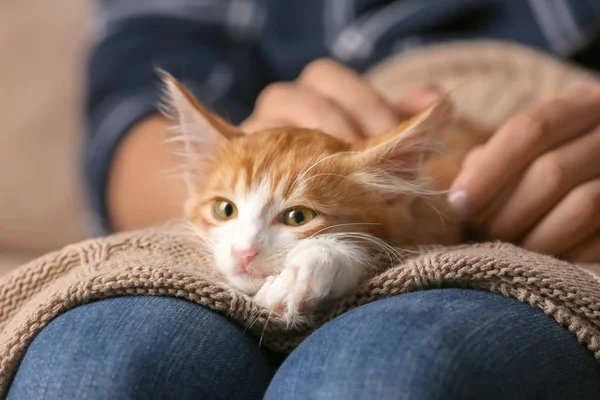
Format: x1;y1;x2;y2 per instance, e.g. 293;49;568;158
241;59;441;142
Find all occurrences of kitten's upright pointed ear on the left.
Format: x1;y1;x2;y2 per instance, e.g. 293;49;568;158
158;71;242;161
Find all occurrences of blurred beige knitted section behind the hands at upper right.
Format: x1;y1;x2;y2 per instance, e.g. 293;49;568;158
367;40;598;131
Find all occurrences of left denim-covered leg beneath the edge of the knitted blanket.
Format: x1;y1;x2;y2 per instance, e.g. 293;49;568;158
8;297;280;400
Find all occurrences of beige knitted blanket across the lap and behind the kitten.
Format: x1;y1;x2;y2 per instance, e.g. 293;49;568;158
0;42;600;395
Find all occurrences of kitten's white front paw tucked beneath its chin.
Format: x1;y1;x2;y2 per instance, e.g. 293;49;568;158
254;238;366;326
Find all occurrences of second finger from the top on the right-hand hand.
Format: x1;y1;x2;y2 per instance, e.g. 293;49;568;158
489;129;600;242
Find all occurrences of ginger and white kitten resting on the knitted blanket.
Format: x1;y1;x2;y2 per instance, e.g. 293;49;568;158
164;75;490;324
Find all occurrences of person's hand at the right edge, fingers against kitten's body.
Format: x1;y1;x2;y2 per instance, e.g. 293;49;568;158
448;86;600;262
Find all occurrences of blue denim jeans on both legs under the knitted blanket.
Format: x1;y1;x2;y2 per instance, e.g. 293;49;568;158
8;289;600;400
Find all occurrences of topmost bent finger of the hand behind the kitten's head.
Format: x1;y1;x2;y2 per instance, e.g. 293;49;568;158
298;59;401;137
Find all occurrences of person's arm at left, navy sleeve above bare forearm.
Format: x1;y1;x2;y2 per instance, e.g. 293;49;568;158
83;0;262;233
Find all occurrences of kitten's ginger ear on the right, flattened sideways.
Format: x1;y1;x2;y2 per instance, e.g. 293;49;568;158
354;96;453;180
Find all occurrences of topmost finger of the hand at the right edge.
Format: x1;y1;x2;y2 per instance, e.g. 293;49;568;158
452;86;600;219
